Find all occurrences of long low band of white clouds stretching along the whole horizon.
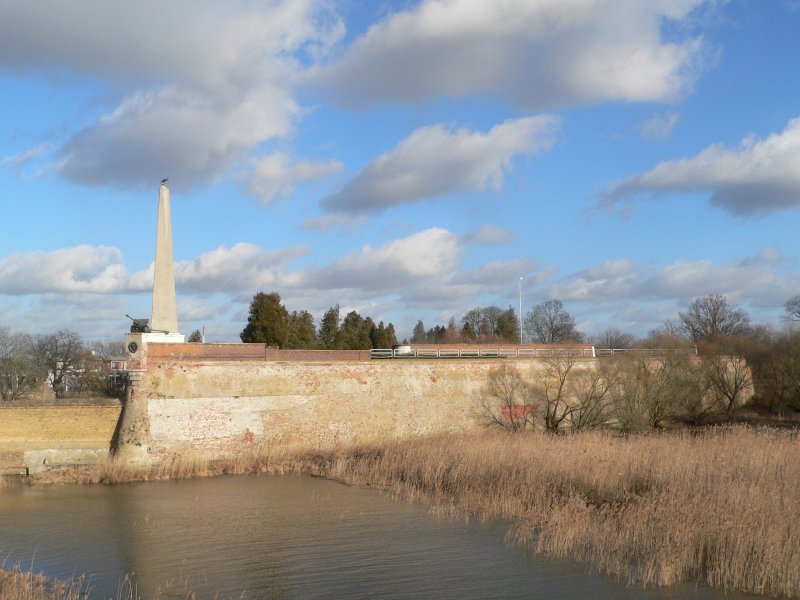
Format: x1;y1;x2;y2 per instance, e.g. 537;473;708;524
0;237;800;340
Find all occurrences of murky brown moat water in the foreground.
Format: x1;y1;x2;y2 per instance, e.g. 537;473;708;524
0;476;752;600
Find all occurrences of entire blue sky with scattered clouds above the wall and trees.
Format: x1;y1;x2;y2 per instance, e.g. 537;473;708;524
0;0;800;342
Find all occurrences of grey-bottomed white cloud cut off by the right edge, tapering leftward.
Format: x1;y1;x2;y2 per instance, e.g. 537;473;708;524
601;118;800;215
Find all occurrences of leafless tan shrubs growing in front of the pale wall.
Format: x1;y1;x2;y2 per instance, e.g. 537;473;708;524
478;353;753;433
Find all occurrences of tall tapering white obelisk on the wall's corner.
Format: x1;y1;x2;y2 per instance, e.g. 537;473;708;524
148;179;184;342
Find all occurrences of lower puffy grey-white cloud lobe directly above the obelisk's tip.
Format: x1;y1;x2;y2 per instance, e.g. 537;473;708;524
58;86;297;189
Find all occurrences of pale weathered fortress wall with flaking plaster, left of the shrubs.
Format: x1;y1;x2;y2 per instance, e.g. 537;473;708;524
136;344;590;455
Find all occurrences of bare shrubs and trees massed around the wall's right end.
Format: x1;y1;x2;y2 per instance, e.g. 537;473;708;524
479;294;800;432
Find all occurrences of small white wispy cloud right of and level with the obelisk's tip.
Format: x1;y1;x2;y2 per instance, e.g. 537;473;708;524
239;152;342;206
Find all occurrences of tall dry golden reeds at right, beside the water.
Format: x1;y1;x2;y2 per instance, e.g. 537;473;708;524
297;428;800;598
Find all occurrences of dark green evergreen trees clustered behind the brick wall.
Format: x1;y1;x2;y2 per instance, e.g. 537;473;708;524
239;292;397;350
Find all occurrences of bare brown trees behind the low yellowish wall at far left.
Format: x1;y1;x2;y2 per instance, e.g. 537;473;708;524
0;327;125;401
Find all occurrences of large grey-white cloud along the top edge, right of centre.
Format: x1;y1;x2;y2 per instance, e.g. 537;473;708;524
312;0;707;108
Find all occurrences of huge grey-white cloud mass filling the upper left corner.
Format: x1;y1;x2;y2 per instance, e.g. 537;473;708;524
0;0;342;187
